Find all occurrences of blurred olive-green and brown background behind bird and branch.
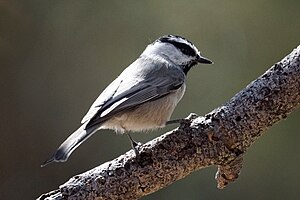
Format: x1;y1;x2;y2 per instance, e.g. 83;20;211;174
0;0;300;200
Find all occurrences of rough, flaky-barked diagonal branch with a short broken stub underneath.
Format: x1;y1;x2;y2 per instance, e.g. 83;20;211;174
38;46;300;200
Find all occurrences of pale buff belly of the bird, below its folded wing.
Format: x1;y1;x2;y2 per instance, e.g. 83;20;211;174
101;85;185;133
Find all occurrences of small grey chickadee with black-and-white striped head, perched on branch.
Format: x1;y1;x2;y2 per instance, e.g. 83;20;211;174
41;35;213;167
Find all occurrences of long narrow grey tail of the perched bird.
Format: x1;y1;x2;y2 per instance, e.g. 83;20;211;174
41;123;98;167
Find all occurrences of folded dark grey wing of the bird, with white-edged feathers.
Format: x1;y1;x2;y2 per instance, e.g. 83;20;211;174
86;70;185;128
